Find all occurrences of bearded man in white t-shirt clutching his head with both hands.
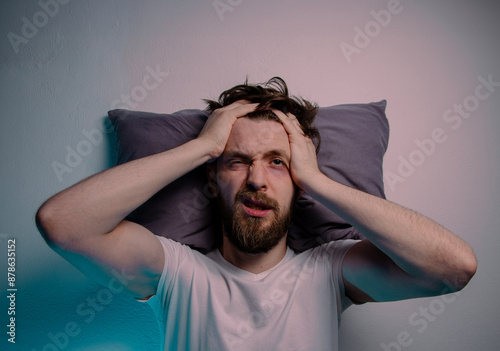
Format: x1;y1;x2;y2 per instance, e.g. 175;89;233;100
37;78;477;350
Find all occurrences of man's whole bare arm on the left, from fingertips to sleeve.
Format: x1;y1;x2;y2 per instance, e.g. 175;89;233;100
36;102;256;297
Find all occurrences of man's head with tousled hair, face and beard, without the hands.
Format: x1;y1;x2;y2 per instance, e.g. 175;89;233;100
207;78;319;254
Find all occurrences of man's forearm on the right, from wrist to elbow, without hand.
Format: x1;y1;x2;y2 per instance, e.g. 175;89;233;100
304;174;476;287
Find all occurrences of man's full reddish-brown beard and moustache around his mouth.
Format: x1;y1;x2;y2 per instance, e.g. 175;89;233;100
218;188;295;254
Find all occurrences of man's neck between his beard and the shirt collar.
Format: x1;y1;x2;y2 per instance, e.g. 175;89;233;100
220;236;287;274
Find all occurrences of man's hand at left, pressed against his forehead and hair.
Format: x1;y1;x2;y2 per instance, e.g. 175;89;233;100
198;100;259;161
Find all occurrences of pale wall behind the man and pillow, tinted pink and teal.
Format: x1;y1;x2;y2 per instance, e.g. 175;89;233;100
0;0;500;351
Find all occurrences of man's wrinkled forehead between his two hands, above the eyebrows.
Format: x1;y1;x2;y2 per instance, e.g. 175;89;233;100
224;117;290;156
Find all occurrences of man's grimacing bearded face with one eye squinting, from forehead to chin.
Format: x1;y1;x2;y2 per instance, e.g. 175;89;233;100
217;117;295;254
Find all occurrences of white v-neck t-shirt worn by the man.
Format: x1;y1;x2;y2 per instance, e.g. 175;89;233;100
147;237;357;351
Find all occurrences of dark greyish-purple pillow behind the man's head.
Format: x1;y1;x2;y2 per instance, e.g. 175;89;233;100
108;100;389;252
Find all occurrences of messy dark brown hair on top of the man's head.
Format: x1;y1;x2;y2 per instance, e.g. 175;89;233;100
204;77;320;150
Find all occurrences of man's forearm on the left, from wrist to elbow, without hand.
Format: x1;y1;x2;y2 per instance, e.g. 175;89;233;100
37;139;210;246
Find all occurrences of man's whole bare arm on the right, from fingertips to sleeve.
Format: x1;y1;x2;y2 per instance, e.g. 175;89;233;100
275;111;477;302
